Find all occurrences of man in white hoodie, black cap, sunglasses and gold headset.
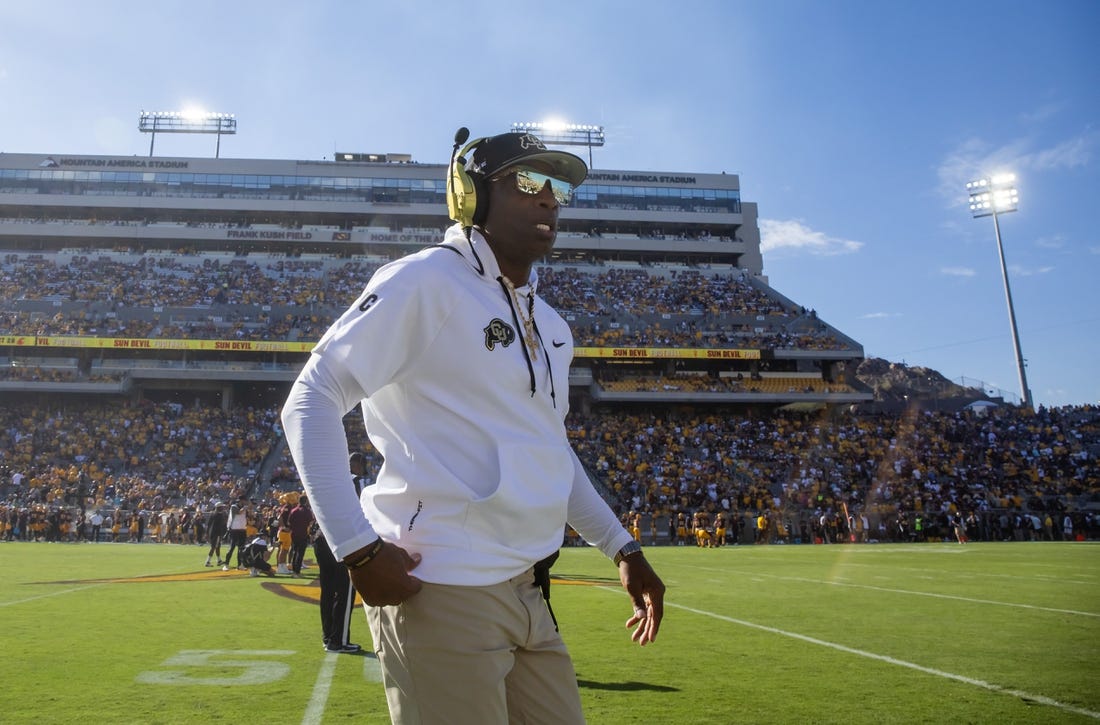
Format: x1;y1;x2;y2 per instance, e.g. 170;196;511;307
283;129;664;723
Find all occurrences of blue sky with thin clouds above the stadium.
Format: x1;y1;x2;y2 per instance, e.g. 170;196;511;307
0;0;1100;406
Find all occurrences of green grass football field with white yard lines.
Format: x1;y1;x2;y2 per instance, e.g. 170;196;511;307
0;542;1100;724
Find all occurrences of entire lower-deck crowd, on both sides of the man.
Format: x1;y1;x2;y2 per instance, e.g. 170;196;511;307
0;402;1100;541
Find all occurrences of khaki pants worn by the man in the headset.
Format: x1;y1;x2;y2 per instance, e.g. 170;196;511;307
366;570;584;725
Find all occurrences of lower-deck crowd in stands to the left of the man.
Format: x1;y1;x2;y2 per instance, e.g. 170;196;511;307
0;399;277;521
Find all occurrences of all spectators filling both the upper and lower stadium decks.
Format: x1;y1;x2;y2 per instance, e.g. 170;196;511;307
0;251;1100;541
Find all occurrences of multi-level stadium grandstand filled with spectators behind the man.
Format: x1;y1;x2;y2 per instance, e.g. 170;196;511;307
0;144;1100;542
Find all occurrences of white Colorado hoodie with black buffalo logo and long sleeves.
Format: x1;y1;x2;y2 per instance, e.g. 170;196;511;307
283;226;630;585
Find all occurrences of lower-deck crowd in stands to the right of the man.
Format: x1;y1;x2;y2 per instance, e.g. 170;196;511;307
572;406;1100;539
